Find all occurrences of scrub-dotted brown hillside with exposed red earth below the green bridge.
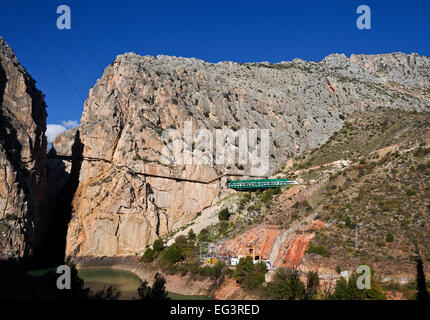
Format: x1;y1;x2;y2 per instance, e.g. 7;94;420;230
203;109;430;282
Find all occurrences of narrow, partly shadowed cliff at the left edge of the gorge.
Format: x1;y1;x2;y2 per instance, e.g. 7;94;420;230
0;38;46;259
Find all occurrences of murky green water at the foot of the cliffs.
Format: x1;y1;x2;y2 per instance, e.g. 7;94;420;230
78;268;209;300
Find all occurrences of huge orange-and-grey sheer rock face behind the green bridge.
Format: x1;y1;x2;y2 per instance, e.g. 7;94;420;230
53;53;430;256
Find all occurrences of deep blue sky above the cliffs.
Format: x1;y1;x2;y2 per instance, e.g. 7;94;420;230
0;0;430;142
